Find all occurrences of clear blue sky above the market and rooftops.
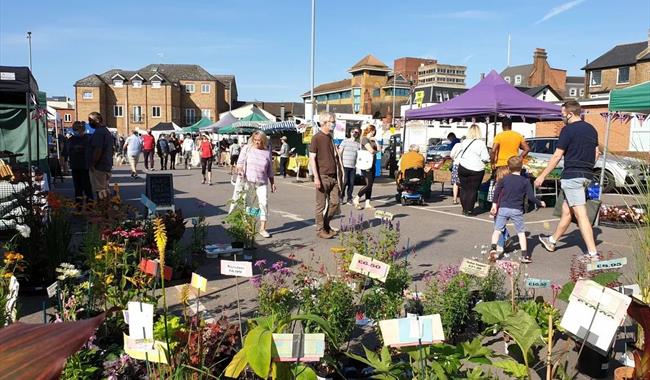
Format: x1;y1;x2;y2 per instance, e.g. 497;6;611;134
0;0;650;101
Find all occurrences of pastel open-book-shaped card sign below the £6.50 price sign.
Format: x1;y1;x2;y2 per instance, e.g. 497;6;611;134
379;314;445;347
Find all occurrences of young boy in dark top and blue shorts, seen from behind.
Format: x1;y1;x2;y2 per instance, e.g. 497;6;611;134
490;156;546;264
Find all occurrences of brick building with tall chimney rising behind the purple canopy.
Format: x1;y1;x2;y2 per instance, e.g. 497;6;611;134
501;48;584;99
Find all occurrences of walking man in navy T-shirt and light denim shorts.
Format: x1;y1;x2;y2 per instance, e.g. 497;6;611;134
535;100;600;259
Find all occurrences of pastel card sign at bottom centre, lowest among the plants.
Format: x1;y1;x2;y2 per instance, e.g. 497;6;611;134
272;334;325;362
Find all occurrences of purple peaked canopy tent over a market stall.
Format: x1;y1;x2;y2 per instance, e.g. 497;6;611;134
406;70;562;143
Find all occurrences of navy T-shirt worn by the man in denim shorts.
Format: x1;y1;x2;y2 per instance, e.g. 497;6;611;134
557;121;598;180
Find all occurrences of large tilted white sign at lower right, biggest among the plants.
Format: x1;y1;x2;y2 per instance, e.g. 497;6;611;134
560;280;632;354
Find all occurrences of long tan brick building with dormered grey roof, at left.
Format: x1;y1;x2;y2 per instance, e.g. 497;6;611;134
74;64;236;135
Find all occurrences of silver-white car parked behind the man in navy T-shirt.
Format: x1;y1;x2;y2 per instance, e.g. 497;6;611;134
526;137;648;192
